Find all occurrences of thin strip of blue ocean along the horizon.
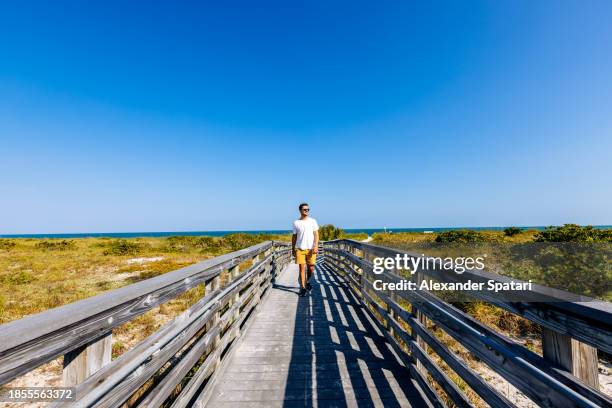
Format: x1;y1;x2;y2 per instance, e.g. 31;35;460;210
0;225;612;238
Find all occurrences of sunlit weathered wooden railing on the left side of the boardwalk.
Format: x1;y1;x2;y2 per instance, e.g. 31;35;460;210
0;241;291;407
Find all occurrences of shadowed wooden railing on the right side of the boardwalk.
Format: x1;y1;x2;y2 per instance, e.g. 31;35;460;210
324;240;612;408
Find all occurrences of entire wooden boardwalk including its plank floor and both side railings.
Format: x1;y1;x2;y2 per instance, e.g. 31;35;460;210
0;239;612;408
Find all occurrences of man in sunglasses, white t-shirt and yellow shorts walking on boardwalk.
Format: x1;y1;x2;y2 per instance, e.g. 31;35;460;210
291;203;319;296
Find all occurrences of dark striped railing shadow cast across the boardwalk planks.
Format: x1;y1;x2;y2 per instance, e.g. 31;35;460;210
283;260;424;407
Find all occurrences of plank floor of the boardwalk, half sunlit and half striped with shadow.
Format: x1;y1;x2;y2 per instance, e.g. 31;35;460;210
207;264;428;407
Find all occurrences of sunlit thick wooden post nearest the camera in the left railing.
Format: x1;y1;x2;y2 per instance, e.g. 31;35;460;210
62;332;113;387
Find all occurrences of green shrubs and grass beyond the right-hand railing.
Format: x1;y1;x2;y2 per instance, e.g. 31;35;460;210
373;224;612;300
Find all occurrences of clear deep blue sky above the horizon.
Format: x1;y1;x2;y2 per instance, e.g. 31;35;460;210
0;0;612;233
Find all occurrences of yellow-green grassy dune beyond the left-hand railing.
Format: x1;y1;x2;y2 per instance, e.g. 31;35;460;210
0;234;289;323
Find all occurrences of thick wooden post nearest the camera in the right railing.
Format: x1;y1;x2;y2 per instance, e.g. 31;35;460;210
542;327;599;389
